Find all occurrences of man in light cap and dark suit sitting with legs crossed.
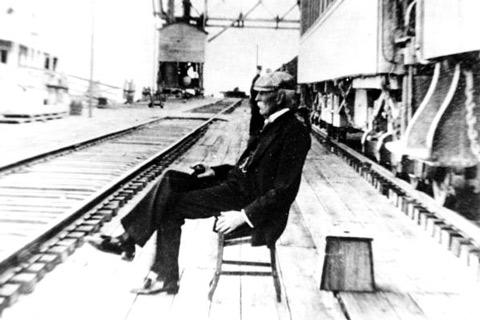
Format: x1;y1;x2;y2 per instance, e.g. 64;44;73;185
89;72;311;294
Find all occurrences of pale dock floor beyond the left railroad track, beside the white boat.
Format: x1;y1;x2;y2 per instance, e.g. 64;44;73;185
0;97;219;166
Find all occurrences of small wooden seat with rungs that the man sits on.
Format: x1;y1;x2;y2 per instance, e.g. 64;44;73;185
208;232;282;302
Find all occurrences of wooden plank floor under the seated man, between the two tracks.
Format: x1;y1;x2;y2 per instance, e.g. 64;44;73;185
2;104;480;320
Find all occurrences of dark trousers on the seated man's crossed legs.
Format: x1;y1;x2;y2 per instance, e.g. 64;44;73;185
122;170;248;280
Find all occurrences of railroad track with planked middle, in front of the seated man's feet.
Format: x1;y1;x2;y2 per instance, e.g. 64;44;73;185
0;100;241;312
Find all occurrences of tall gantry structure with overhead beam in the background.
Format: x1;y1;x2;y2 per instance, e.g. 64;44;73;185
148;0;300;98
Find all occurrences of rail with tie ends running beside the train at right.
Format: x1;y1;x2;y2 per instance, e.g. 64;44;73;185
313;128;480;279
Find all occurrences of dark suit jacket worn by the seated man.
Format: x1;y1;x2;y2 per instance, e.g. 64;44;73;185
214;111;311;245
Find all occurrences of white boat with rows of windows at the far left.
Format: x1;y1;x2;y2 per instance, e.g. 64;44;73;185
0;2;70;122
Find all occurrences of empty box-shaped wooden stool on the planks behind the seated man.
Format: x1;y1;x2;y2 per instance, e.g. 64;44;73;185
320;236;375;292
